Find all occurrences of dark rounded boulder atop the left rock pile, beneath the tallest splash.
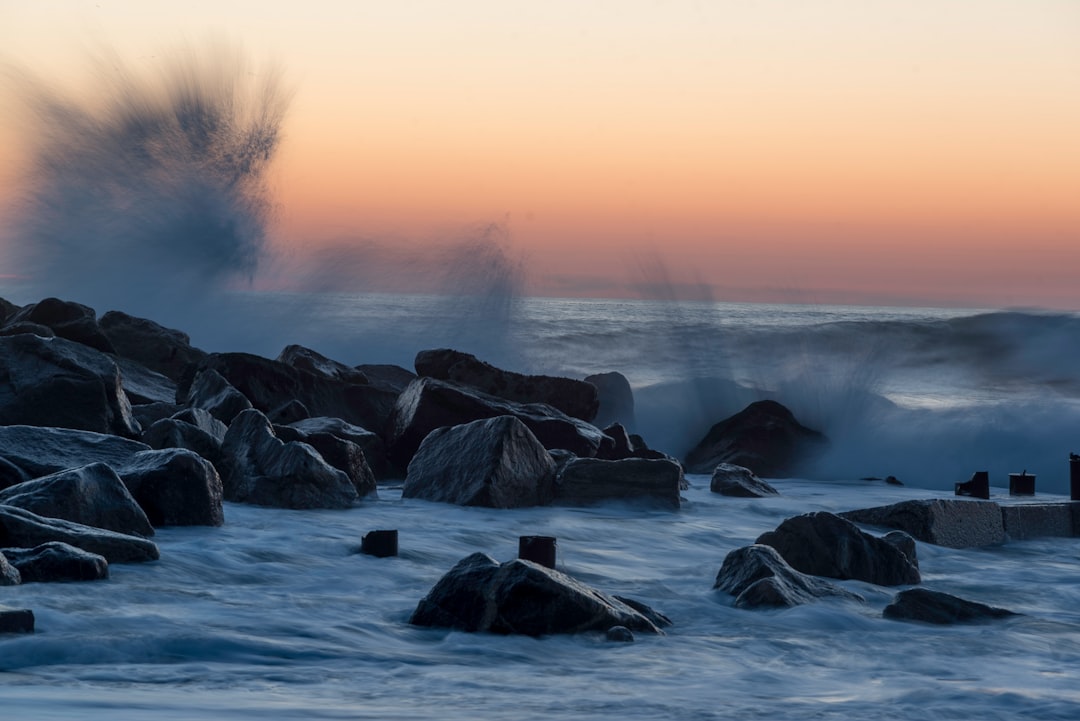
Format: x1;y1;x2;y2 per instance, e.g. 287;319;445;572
99;311;206;382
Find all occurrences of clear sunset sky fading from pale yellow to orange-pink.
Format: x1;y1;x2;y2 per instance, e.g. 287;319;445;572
0;0;1080;310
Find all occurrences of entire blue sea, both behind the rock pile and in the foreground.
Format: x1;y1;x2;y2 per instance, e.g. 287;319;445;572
6;294;1080;721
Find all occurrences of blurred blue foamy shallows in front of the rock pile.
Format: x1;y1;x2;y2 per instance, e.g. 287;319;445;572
0;476;1080;720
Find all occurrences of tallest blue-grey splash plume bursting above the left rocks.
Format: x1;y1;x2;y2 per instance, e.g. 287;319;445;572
9;43;289;325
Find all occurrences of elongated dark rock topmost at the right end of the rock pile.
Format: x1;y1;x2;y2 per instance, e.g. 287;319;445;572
416;348;599;422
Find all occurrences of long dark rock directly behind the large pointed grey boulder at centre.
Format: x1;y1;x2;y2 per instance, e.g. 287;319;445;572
387;378;611;466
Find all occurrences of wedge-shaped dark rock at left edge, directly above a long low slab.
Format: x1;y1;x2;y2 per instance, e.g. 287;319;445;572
0;463;153;536
